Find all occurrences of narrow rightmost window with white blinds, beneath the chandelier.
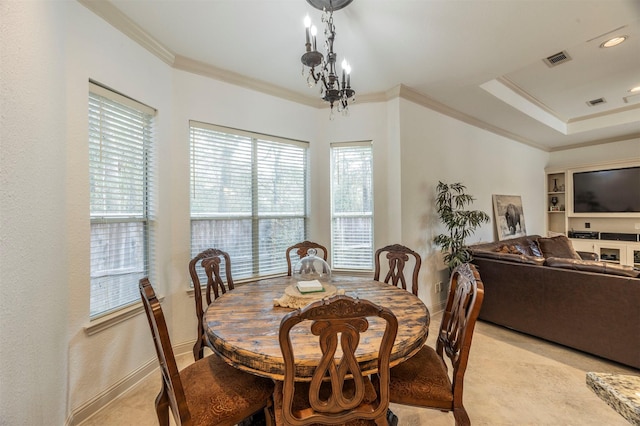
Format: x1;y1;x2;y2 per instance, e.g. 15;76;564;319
331;142;373;270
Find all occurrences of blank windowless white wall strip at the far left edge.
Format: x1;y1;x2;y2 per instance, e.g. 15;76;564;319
0;1;71;425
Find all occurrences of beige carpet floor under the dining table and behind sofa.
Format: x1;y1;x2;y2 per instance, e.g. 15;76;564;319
82;316;640;426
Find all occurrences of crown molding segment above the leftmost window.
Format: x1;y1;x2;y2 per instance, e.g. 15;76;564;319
78;0;175;66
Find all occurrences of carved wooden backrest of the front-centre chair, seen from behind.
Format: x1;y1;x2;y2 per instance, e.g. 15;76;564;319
279;295;398;425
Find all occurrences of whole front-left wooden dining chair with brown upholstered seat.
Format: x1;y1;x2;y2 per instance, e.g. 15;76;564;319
139;278;274;426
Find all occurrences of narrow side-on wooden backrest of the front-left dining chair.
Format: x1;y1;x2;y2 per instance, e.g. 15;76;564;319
138;278;191;425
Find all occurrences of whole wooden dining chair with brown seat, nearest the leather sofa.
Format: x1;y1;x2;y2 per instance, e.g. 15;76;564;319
374;263;484;425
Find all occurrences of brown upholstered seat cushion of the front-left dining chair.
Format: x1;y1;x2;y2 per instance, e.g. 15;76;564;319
180;355;274;426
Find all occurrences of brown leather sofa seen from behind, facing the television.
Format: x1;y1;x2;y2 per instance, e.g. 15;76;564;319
469;235;640;368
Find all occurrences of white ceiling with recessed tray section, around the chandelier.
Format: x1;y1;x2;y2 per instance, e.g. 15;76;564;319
85;0;640;151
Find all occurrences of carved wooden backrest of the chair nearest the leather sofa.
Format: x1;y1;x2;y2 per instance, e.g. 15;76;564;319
436;263;484;401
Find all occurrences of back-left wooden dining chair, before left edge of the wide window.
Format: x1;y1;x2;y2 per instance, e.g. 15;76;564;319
189;248;234;361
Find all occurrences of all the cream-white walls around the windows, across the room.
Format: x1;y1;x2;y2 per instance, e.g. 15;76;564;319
0;1;633;425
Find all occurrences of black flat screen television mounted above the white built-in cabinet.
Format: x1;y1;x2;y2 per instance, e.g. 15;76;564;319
573;166;640;213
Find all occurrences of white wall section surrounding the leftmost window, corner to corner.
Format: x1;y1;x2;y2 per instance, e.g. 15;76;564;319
62;2;173;420
